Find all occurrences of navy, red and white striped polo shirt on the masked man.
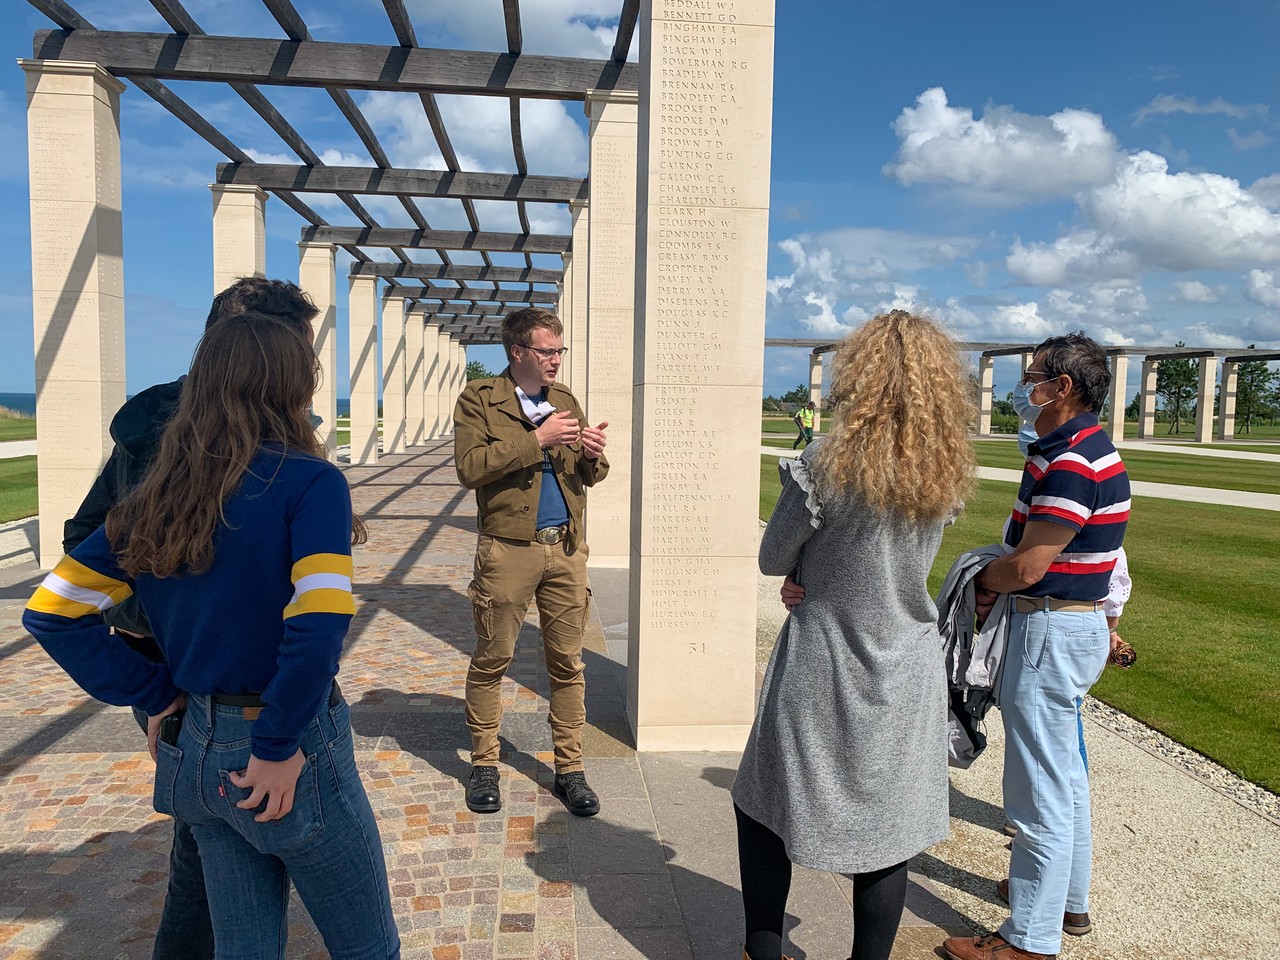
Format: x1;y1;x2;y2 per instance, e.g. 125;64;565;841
1005;413;1129;600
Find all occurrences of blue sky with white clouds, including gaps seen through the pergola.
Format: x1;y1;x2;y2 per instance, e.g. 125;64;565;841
0;0;1280;392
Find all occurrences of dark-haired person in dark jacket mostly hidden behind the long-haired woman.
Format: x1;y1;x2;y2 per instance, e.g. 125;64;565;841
63;276;317;960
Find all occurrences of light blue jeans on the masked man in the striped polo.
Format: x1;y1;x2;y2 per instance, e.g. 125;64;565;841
1000;609;1108;954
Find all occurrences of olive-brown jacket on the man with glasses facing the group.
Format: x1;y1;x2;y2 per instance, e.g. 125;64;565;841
453;370;609;553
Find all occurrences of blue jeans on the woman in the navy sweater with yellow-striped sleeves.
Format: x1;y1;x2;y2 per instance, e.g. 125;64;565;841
152;695;401;960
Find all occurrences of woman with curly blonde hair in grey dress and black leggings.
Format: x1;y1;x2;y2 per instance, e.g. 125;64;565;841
733;310;974;960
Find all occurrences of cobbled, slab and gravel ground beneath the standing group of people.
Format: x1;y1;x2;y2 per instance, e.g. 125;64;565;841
0;443;1280;960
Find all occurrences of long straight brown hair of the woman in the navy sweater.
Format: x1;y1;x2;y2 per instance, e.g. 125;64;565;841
106;311;366;577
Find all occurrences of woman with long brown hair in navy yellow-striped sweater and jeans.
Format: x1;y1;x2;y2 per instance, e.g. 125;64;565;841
23;312;399;960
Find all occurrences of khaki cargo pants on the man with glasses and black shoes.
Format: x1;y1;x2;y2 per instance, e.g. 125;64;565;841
467;534;590;773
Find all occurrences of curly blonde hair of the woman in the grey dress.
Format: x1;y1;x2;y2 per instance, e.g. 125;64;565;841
815;310;974;521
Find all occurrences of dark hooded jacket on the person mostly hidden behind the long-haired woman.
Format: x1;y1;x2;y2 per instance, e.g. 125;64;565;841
63;376;187;650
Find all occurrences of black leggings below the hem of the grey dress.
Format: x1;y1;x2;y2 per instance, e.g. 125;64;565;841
733;804;906;960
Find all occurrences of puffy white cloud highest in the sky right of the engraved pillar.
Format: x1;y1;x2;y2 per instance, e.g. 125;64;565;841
883;87;1117;201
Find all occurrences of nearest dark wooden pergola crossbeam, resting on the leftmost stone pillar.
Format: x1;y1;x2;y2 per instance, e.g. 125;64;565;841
33;29;640;100
